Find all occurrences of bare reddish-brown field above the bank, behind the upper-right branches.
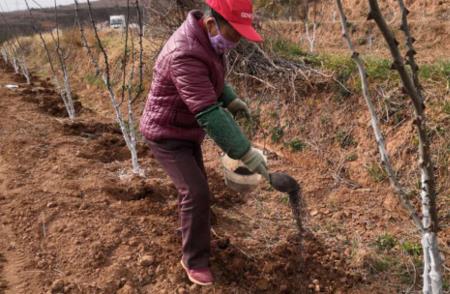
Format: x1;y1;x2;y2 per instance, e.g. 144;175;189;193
263;0;450;63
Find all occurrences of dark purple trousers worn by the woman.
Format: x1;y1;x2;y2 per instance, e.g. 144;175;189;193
147;140;211;269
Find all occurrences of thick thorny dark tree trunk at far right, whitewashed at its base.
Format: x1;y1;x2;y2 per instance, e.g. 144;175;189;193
368;0;443;294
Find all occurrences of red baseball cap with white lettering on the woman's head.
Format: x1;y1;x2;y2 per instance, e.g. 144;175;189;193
206;0;263;42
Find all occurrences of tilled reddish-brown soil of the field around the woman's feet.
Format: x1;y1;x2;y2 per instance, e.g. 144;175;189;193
0;54;445;293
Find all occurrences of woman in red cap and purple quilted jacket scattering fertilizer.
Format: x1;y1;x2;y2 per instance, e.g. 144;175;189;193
140;0;267;285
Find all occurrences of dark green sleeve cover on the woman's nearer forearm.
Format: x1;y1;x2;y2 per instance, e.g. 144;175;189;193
196;104;251;159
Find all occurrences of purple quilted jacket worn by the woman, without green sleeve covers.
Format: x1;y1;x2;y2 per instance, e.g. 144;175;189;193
140;11;225;142
